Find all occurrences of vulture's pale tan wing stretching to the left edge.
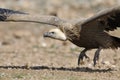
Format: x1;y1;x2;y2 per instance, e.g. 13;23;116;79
0;8;64;26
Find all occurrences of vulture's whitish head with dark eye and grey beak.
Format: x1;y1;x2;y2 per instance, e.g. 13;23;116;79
43;29;67;41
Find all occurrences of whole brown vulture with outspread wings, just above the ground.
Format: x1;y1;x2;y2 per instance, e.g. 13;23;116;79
0;6;120;65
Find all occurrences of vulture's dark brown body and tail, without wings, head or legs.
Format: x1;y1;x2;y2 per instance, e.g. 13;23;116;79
63;24;120;49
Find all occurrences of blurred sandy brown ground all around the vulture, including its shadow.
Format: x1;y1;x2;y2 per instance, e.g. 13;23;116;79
0;0;120;80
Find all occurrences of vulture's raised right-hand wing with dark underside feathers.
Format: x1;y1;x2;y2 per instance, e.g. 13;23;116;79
78;6;120;31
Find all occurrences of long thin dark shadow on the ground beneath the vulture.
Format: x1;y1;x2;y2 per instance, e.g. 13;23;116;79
0;66;113;72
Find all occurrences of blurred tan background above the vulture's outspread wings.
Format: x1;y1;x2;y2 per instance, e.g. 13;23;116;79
0;0;120;19
